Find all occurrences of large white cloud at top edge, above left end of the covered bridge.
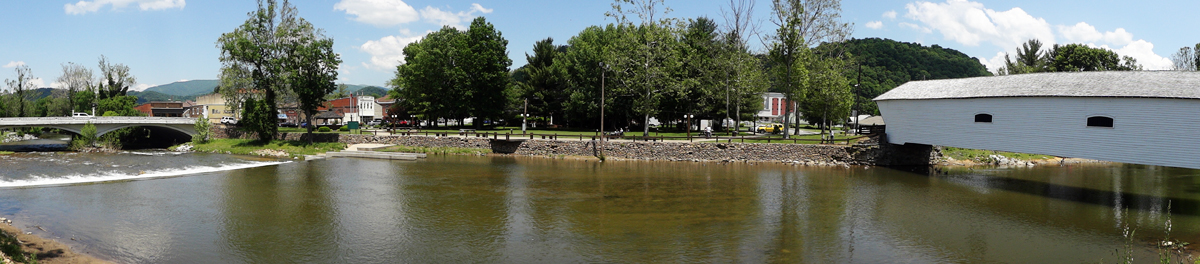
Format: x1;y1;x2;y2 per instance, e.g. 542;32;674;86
905;0;1055;49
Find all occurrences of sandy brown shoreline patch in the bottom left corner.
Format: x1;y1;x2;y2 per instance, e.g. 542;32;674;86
0;218;113;264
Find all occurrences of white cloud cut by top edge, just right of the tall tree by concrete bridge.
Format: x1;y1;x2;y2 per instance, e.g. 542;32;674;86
334;0;420;26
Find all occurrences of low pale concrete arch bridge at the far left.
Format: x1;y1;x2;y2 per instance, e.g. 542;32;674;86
0;116;196;137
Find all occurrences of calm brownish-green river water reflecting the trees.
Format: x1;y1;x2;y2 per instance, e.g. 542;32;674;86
0;151;1200;263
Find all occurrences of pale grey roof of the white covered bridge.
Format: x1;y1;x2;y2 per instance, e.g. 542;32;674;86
875;71;1200;101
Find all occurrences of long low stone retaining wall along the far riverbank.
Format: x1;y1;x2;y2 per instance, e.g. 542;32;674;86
214;130;940;166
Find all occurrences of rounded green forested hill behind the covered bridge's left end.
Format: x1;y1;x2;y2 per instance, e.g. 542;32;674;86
846;38;991;115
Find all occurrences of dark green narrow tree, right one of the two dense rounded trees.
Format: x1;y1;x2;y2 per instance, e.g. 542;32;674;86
463;17;512;128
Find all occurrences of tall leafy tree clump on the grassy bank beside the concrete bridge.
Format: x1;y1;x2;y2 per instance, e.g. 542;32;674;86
217;0;341;142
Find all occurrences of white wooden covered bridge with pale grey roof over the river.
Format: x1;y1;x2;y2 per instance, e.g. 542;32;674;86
875;72;1200;169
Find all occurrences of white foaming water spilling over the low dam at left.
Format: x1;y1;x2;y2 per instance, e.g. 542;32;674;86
0;161;290;188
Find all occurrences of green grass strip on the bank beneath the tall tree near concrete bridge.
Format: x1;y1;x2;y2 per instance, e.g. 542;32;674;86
192;138;346;156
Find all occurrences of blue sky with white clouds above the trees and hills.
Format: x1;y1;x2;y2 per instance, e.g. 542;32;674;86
0;0;1200;90
